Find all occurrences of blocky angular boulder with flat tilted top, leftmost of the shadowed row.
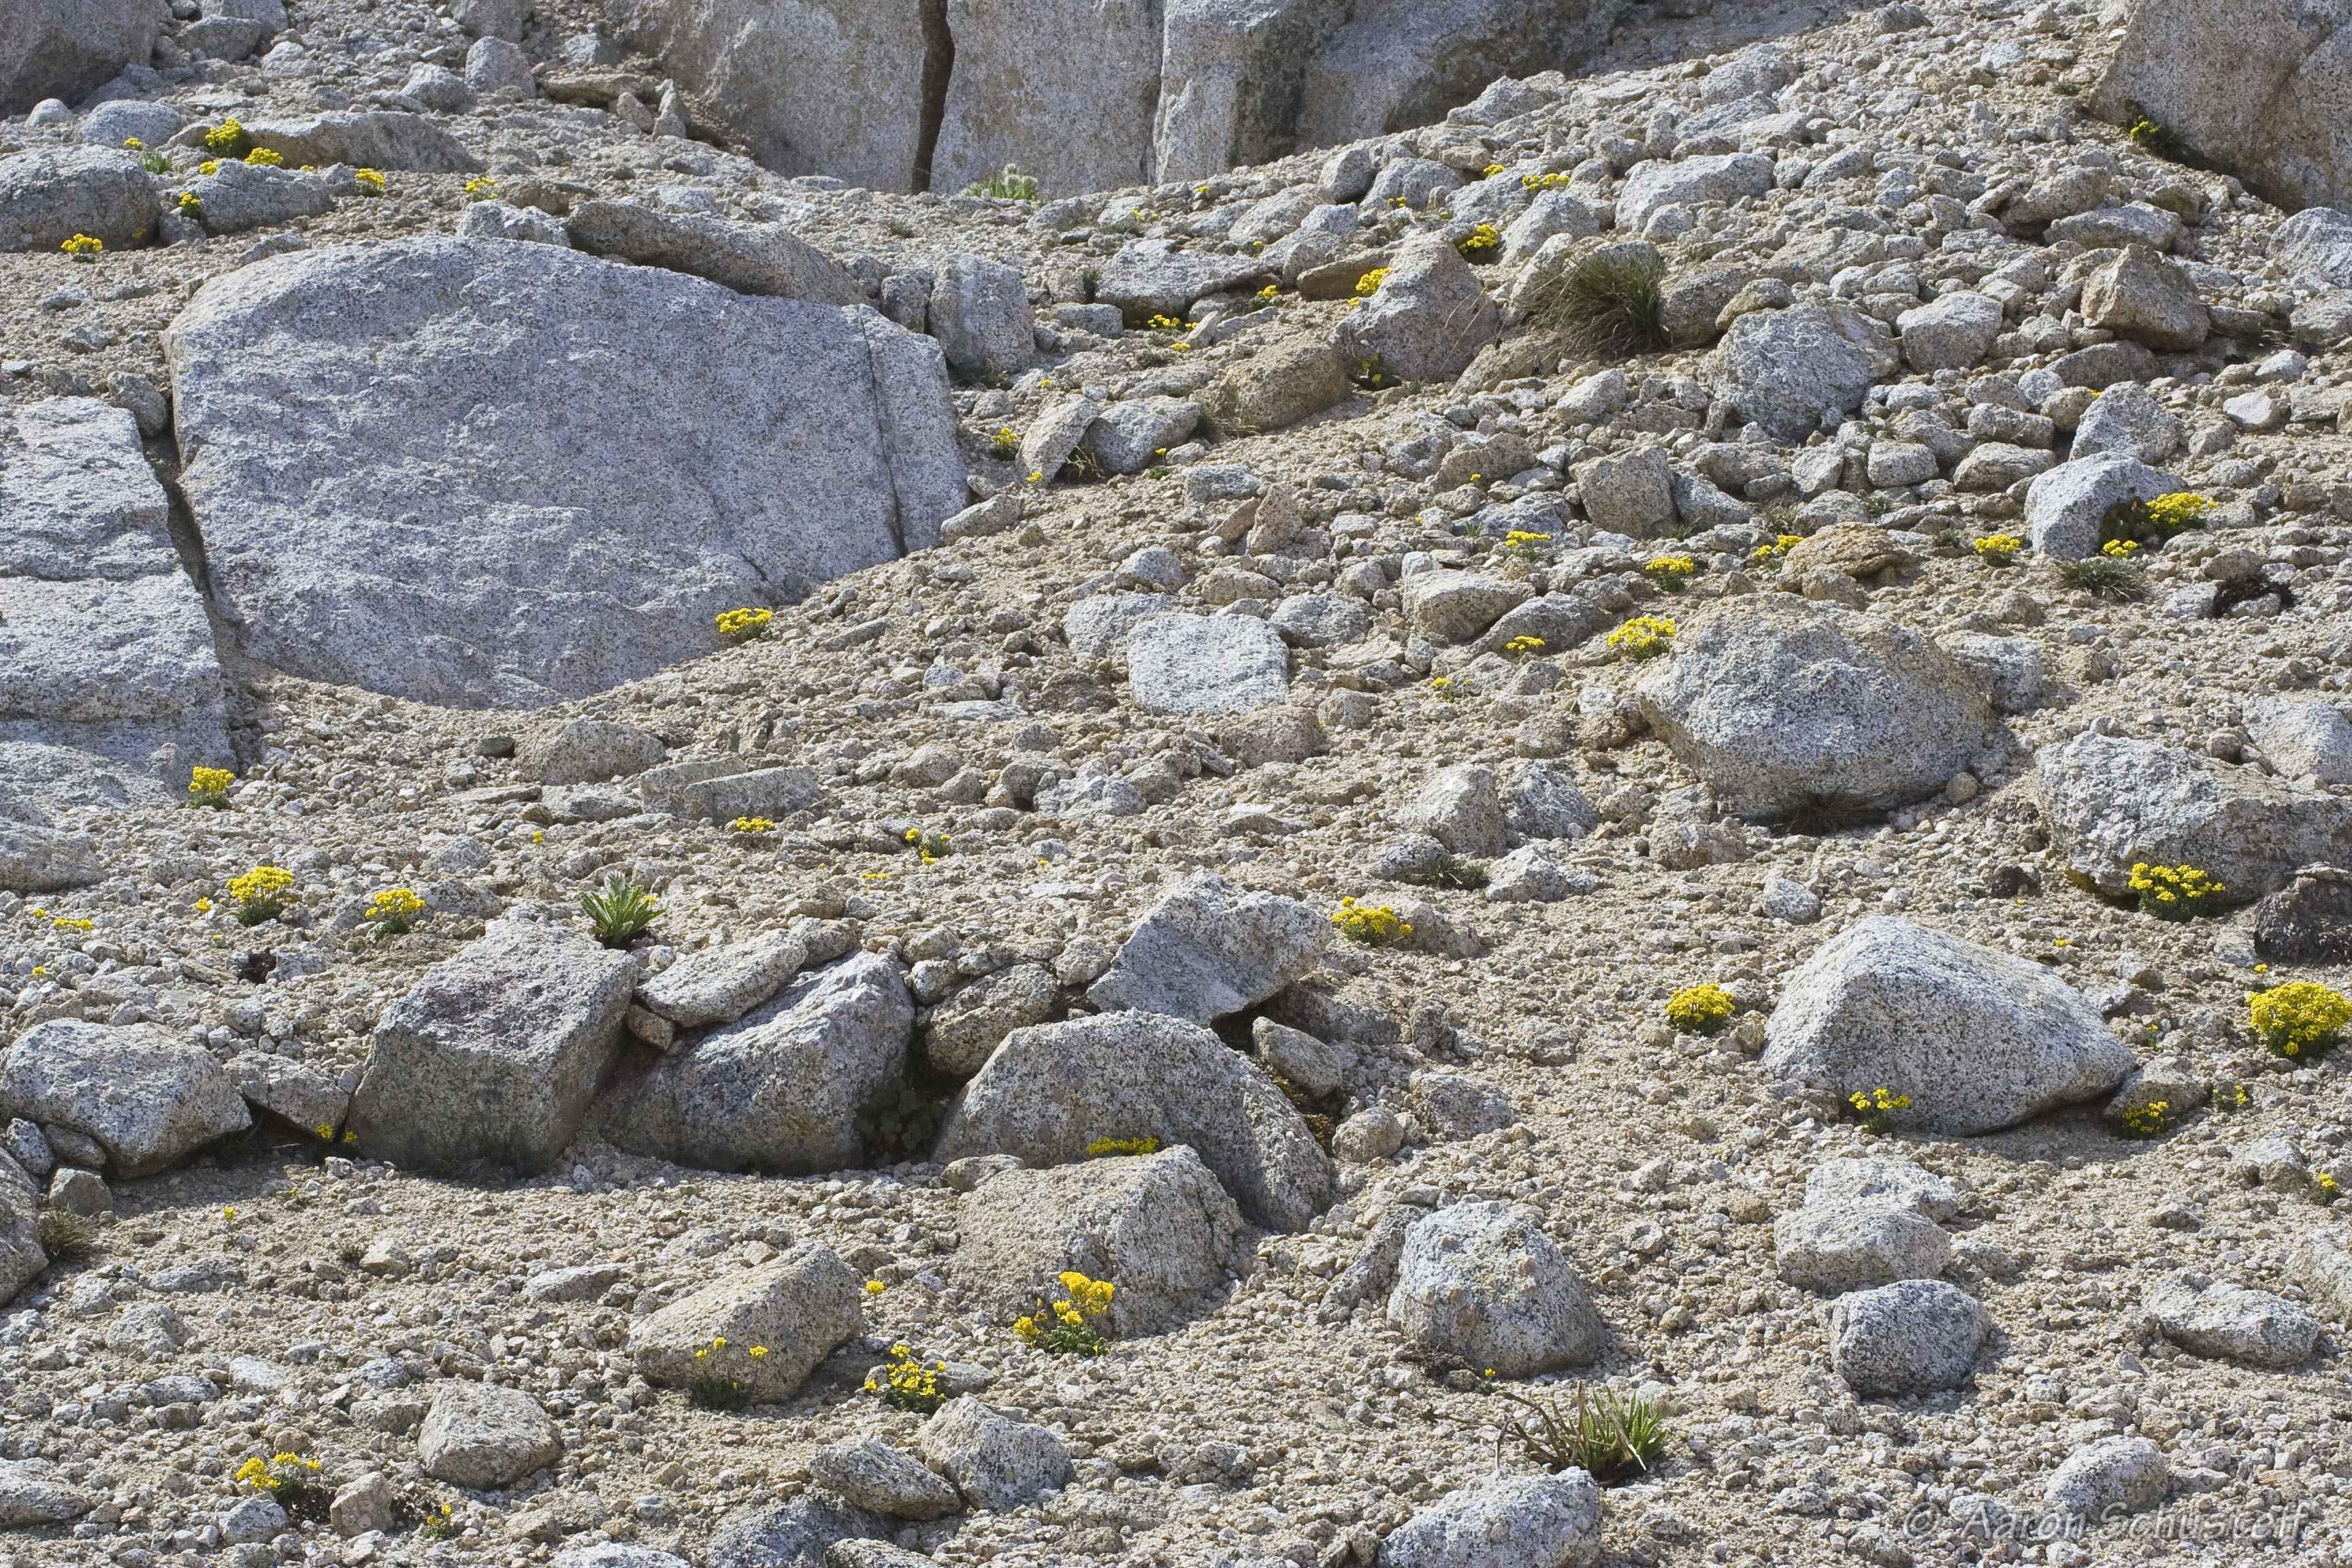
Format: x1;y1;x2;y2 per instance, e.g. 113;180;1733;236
350;919;638;1173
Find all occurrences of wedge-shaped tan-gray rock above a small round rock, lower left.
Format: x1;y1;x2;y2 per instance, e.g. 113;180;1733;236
628;1243;866;1403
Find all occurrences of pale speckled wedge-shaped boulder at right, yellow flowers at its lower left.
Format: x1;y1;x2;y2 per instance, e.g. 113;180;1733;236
1764;915;2138;1135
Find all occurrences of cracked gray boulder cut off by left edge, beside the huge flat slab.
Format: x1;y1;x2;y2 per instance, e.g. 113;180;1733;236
0;392;233;785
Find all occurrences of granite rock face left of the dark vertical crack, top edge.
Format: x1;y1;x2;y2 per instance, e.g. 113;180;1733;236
607;0;926;191
